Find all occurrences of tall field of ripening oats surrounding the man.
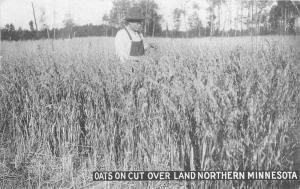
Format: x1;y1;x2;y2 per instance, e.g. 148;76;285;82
0;36;300;188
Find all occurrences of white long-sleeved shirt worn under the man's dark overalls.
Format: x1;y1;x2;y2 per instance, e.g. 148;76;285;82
115;27;146;62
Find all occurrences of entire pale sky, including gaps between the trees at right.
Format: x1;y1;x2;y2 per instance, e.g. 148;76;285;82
0;0;276;31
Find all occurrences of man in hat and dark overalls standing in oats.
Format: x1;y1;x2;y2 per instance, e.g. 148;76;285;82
115;7;154;62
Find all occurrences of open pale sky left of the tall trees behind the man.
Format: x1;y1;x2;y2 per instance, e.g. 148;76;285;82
0;0;112;29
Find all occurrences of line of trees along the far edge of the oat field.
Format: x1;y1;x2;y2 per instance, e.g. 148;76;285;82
1;0;300;40
